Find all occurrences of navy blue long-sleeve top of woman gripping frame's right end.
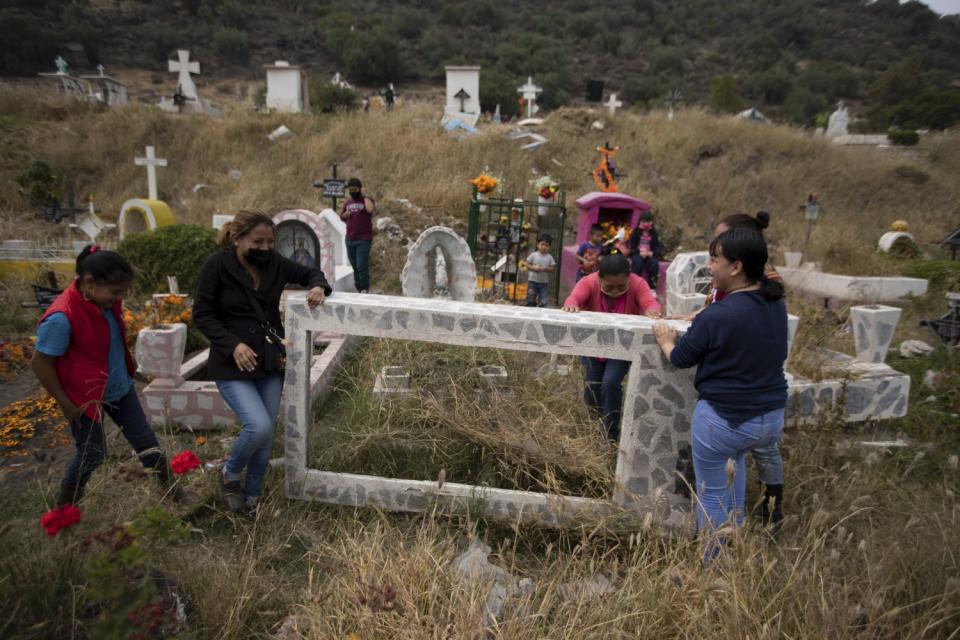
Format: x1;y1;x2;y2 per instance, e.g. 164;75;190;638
670;291;787;427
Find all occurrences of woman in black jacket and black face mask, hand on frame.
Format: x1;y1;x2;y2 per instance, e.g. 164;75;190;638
193;211;331;511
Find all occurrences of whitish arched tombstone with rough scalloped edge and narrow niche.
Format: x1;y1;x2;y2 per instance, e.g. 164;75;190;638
400;226;477;302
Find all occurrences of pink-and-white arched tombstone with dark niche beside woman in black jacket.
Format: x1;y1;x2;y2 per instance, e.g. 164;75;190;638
273;209;353;291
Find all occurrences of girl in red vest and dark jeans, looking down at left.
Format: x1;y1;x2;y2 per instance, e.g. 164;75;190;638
31;245;188;506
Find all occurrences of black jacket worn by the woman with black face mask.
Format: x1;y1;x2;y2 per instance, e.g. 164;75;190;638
193;248;332;380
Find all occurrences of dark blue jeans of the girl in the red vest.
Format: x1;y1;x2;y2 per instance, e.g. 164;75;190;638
63;386;161;487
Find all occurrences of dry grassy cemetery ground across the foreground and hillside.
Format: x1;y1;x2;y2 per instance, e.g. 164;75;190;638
0;89;960;639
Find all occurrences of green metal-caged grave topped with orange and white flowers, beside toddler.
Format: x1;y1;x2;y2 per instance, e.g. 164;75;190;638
467;173;567;304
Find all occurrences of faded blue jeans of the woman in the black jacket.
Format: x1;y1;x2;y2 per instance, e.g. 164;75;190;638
217;375;283;498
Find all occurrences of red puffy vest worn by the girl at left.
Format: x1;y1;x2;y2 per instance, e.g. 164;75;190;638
40;280;137;421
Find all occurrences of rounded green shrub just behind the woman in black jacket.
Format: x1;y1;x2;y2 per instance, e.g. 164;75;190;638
117;224;218;295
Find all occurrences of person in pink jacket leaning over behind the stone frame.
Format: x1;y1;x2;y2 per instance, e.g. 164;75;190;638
563;253;660;441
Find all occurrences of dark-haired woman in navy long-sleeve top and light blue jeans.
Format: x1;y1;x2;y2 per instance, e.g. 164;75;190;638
654;228;787;561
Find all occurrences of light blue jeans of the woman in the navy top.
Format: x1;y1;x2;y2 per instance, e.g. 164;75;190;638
691;400;784;557
